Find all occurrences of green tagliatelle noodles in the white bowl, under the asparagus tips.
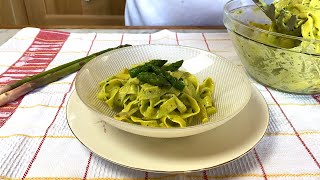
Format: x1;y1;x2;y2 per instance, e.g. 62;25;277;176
97;60;216;128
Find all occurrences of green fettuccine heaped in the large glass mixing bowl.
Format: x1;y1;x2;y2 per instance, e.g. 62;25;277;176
249;0;320;54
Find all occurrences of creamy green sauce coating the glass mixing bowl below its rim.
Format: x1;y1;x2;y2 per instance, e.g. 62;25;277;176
229;32;320;94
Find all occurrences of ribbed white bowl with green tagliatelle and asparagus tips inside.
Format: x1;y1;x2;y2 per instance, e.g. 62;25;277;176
75;45;251;138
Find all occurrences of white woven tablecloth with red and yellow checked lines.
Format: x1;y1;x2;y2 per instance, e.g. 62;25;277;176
0;28;320;180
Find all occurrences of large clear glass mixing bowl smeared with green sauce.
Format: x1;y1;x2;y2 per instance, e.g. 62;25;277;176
223;0;320;94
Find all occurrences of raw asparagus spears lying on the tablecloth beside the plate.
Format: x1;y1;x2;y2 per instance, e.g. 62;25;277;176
0;44;131;106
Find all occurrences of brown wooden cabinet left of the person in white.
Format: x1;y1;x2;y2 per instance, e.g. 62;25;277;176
0;0;125;26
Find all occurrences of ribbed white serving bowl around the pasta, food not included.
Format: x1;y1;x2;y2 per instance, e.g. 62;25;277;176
75;45;251;138
